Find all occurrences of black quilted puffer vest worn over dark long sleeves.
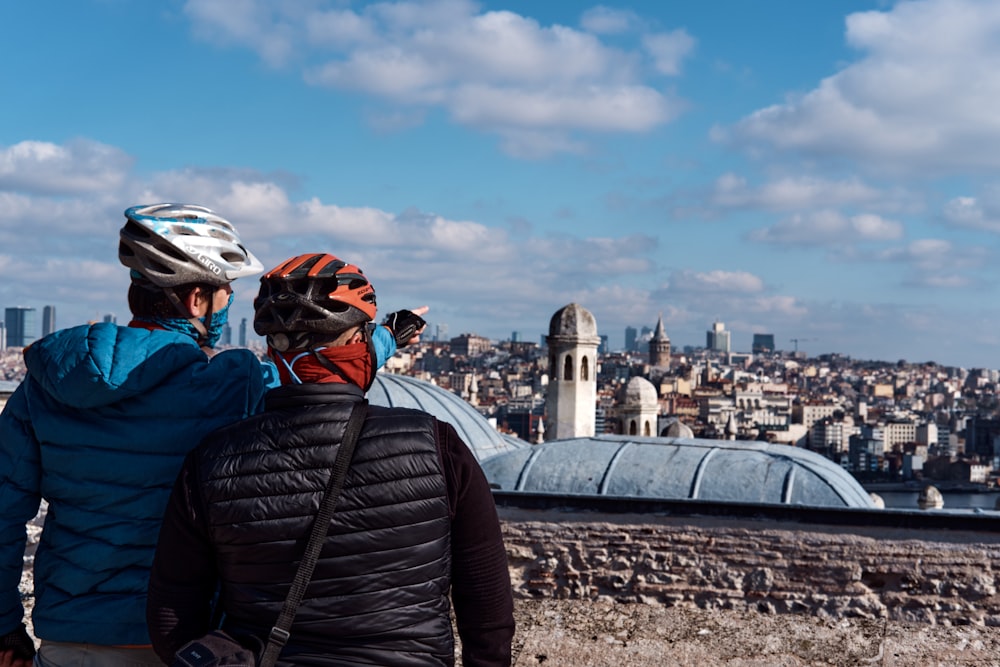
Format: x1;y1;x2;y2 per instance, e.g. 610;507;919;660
159;385;453;665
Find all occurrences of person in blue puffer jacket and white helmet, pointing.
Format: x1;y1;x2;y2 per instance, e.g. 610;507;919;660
0;204;422;667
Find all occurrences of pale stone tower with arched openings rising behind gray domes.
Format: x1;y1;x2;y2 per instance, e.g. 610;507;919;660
545;303;601;440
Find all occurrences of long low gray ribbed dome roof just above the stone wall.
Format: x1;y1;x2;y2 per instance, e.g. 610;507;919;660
483;435;874;508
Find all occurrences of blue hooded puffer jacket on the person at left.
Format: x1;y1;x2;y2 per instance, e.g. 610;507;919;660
0;324;276;645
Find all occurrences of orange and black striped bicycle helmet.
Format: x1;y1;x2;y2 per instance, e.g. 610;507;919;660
253;253;376;351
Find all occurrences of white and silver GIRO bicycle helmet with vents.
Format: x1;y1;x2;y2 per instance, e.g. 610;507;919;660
118;204;264;288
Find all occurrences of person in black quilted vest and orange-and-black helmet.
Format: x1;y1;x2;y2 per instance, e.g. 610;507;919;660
147;254;514;667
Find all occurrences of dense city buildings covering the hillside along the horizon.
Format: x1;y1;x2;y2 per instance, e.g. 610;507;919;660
7;306;1000;491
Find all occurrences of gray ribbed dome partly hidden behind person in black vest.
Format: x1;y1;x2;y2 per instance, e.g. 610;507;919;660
368;372;528;462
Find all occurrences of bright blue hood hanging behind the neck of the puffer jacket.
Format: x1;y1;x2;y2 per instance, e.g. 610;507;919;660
24;322;208;408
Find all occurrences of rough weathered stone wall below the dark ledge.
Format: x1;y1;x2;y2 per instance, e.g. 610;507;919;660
499;507;1000;626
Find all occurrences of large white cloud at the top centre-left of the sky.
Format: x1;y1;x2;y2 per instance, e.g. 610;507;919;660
186;0;695;157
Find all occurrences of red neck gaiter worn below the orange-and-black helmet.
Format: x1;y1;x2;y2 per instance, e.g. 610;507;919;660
267;342;376;391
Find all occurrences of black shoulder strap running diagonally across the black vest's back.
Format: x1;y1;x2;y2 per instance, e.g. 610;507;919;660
258;400;368;667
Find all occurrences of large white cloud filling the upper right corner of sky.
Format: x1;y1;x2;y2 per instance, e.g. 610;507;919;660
713;0;1000;171
